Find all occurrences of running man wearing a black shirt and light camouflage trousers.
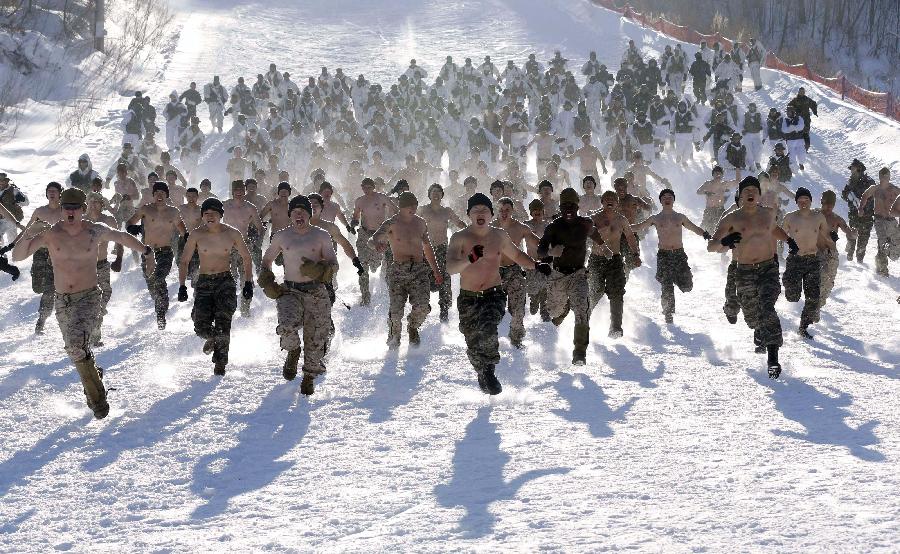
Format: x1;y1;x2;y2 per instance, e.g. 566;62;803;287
537;188;615;365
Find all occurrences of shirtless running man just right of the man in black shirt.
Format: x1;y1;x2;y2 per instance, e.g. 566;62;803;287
588;188;642;339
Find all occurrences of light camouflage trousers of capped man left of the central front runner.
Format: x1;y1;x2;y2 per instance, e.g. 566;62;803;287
387;262;432;344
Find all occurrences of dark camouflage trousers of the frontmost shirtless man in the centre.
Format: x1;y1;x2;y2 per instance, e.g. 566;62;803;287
456;286;506;372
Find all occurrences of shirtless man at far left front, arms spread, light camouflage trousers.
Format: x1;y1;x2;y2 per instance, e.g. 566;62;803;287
13;188;153;419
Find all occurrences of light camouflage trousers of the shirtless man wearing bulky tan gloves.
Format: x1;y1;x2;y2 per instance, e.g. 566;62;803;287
275;281;331;374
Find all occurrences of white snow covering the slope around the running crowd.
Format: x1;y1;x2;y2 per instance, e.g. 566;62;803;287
0;0;900;552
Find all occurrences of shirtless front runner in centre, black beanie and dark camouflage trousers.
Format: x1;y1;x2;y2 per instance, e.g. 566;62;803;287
447;192;548;395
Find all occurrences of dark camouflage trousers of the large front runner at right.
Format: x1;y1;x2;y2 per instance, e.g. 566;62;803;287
734;257;783;346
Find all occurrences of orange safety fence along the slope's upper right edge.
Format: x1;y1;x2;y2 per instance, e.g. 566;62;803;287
591;0;900;121
